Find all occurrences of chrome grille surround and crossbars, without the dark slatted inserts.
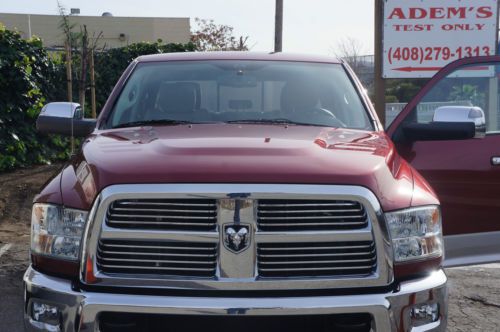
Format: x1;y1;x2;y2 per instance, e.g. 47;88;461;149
80;184;393;290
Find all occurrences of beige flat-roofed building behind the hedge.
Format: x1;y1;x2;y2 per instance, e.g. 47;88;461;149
0;13;190;48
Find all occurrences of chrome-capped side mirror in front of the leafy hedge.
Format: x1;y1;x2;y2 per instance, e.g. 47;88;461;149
36;102;97;137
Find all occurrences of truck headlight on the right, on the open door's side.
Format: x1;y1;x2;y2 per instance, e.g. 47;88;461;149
386;206;443;262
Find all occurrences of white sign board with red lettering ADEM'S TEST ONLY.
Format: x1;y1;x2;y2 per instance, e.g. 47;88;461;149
383;0;498;78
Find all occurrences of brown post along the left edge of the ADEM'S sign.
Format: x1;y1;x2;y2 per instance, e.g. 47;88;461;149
374;0;385;127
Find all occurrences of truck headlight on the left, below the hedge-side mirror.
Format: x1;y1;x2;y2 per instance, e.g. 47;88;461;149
31;203;88;260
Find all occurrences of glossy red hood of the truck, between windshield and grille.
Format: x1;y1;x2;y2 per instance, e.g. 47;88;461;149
57;124;426;210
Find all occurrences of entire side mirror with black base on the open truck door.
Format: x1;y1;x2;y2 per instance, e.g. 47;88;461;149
403;106;486;141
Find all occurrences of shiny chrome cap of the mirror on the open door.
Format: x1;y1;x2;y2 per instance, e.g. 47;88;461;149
433;106;486;138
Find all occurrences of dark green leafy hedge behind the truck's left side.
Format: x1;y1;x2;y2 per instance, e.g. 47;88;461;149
0;26;195;172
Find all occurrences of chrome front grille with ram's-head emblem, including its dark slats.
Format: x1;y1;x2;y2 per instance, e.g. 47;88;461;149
85;184;392;290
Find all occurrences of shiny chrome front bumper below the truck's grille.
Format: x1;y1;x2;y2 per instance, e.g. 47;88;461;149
24;267;448;332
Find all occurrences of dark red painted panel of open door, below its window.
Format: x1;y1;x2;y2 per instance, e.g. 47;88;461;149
399;136;500;235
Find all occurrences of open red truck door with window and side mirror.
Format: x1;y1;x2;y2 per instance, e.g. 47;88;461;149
387;56;500;266
